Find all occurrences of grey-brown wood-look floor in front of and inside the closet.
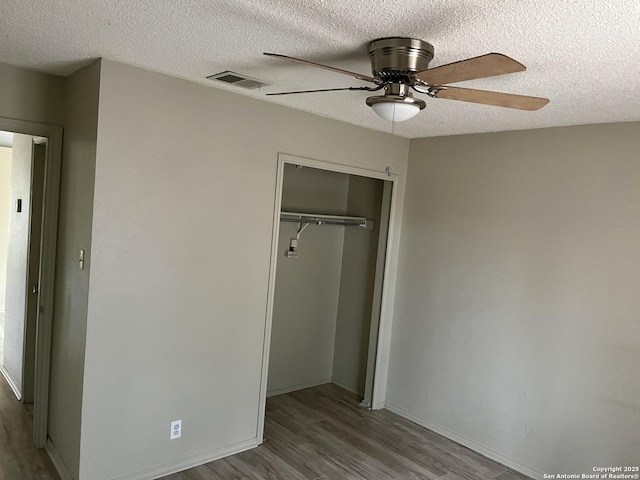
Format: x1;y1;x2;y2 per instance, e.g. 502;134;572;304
163;384;529;480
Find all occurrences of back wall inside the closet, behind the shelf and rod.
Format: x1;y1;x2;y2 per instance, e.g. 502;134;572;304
267;165;349;395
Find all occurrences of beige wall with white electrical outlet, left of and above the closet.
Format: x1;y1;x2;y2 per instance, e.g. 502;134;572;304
80;60;408;479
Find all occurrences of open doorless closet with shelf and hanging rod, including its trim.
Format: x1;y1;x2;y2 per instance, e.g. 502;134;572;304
259;155;396;438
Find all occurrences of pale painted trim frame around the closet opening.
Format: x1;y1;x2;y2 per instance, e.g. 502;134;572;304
256;153;401;443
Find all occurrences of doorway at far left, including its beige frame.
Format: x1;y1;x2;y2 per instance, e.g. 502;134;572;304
0;118;62;448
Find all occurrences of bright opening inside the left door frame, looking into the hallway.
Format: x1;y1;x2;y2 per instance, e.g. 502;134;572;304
0;132;47;404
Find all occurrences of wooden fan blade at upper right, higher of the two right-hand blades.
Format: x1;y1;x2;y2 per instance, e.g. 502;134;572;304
416;53;527;85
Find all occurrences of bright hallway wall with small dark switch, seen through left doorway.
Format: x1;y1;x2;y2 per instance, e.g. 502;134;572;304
3;134;33;396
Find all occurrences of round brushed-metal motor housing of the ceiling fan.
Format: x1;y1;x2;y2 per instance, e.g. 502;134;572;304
367;37;434;80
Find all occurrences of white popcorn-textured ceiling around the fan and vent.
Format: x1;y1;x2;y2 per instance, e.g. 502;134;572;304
0;0;640;138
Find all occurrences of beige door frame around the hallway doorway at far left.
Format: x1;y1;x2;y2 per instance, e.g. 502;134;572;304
0;117;62;448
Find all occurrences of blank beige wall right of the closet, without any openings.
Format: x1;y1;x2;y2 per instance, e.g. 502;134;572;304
387;123;640;473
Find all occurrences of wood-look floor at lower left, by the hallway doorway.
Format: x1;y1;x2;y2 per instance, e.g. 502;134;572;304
0;374;60;480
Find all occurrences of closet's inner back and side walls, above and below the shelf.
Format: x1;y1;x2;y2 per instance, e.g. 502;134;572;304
267;164;383;396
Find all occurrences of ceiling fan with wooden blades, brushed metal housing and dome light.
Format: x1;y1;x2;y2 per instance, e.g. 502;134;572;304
265;37;549;122
